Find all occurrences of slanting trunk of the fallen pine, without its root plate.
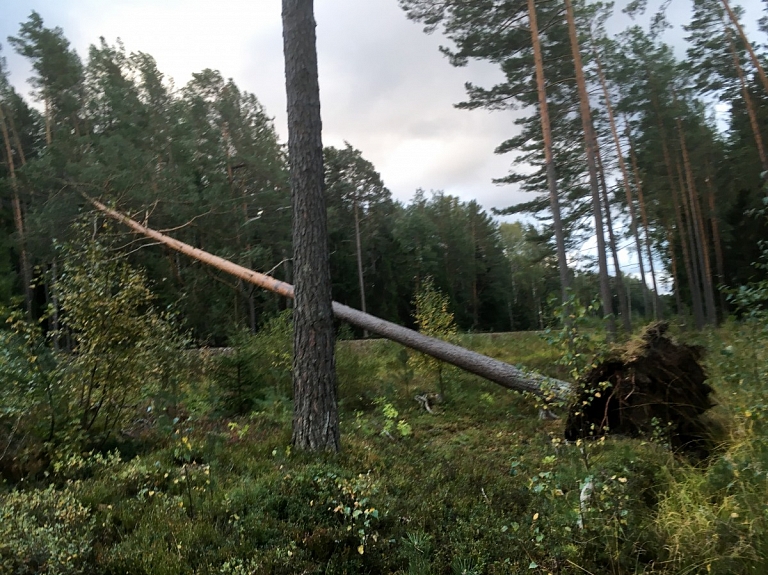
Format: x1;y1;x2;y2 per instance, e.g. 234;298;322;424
83;194;571;398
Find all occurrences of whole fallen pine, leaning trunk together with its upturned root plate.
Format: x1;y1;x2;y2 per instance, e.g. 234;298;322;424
83;194;714;450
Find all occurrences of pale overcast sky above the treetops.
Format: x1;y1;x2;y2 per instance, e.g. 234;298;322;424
0;0;762;216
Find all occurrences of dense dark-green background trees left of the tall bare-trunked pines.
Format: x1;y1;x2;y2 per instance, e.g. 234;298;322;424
0;13;584;344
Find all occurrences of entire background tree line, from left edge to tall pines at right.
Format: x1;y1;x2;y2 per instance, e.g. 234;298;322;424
0;0;768;344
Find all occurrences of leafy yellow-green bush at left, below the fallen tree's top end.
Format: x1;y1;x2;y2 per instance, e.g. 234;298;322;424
52;228;186;441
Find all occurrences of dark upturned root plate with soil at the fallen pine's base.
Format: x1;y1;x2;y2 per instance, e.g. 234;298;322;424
565;322;715;455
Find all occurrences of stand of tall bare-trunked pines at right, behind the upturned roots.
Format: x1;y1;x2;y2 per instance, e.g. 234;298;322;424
400;0;768;331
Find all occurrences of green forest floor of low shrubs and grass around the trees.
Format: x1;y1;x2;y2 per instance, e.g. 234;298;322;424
0;324;768;575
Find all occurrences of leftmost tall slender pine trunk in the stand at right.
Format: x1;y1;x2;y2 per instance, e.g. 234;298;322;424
528;0;571;310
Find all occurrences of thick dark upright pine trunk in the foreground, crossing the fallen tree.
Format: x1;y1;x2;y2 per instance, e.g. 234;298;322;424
283;0;339;451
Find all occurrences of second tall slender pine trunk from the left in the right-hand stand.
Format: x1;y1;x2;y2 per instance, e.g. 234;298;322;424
565;0;616;339
